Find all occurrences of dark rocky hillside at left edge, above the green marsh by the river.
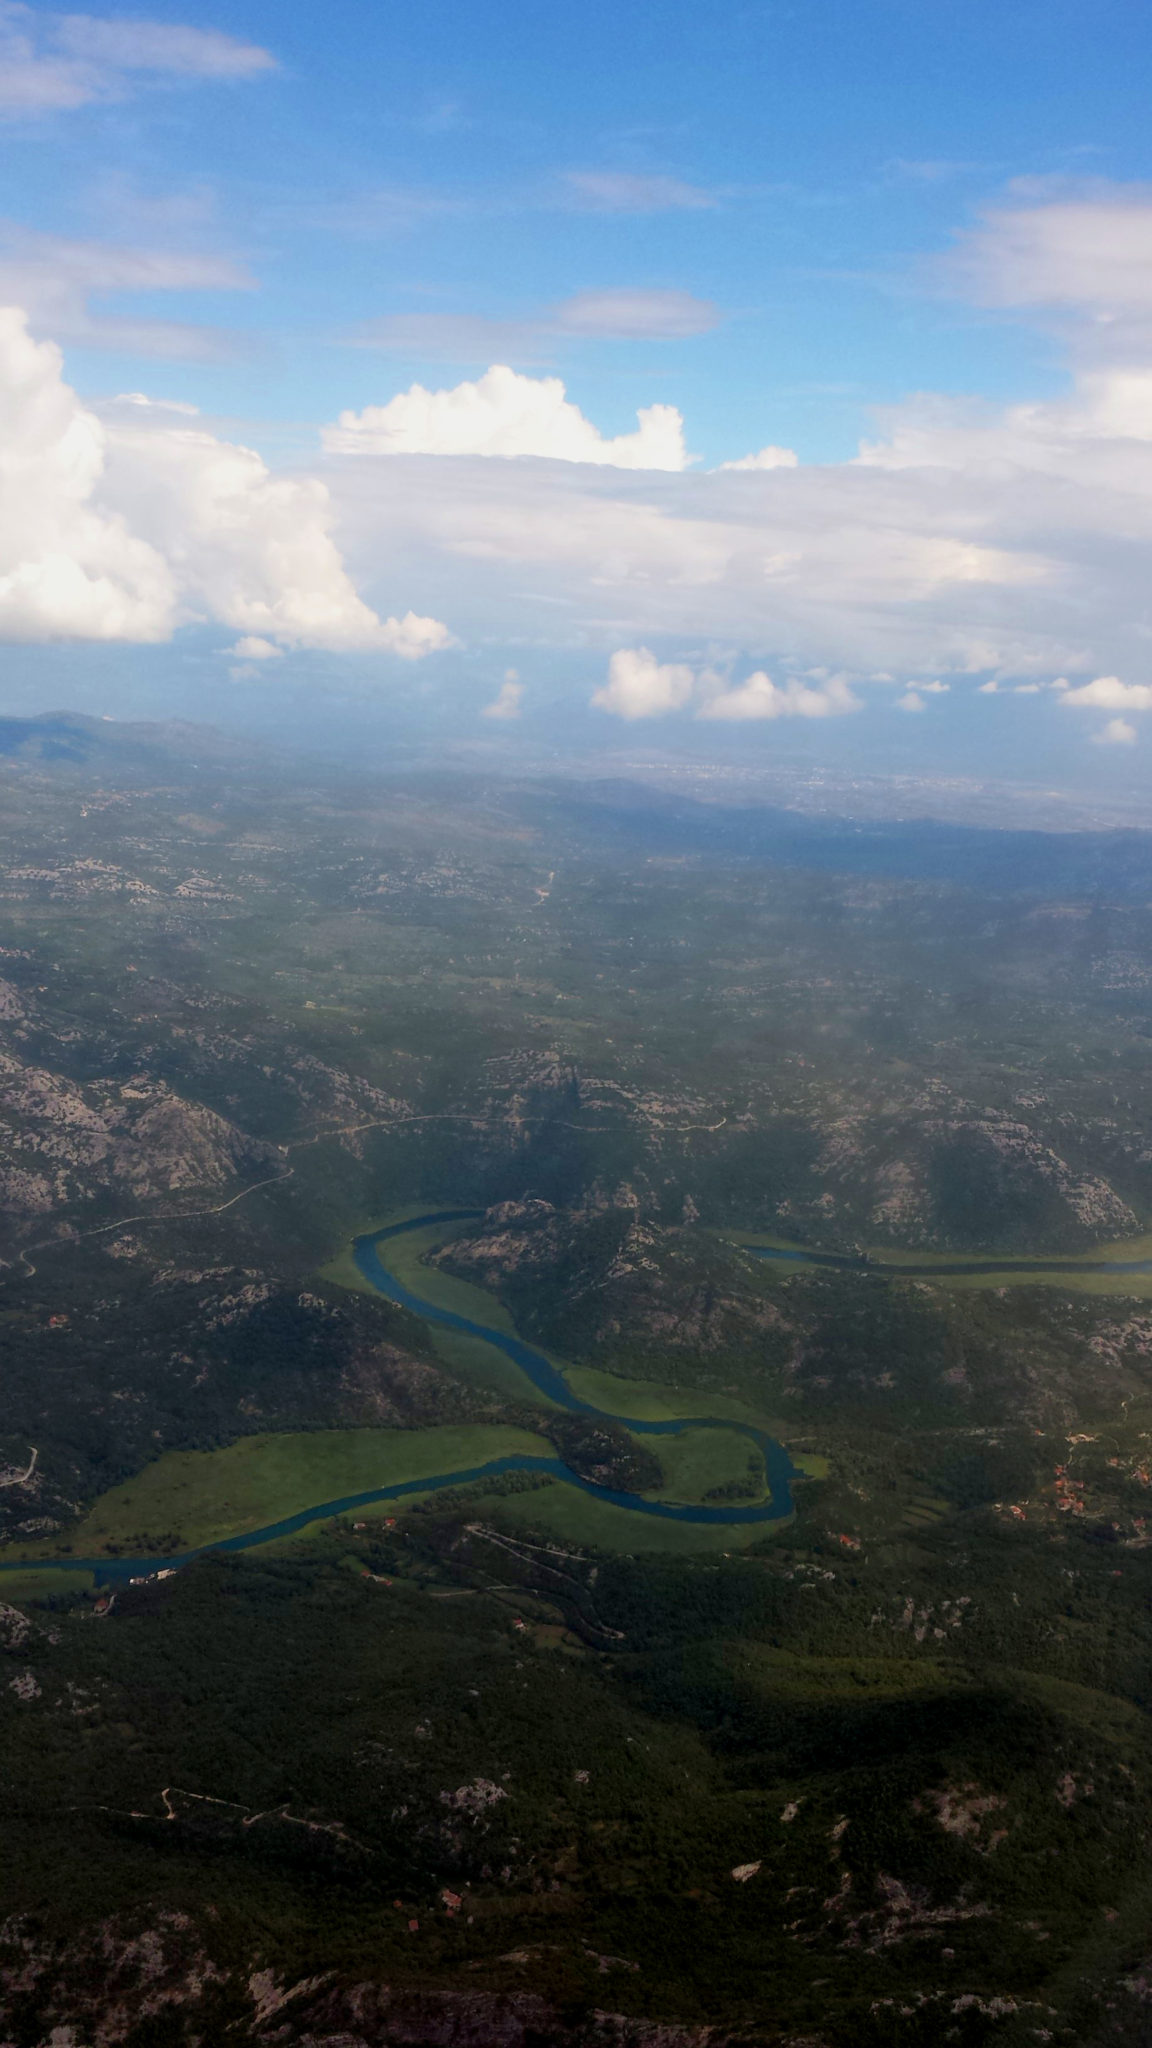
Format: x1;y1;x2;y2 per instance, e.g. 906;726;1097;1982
0;1233;478;1550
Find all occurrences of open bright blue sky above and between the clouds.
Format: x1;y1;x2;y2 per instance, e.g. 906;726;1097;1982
6;0;1152;448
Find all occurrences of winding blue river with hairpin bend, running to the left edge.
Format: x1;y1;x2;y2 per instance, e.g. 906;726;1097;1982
0;1208;799;1585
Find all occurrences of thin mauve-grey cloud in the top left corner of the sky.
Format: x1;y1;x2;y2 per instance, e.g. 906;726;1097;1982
0;0;277;115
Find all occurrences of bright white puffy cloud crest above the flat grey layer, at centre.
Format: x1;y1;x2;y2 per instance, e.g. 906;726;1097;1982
324;365;687;469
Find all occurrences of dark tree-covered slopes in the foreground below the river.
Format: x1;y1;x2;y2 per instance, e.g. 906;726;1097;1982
0;1531;1152;2048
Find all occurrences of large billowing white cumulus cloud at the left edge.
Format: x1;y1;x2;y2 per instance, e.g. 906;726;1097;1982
0;307;449;657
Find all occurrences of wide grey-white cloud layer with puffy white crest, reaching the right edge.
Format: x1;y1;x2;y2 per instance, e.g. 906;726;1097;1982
319;203;1152;688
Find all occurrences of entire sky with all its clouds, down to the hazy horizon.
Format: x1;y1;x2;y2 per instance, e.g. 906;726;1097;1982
0;0;1152;788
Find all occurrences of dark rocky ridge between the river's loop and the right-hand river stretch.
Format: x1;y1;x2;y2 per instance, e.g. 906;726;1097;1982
430;1198;1152;1430
